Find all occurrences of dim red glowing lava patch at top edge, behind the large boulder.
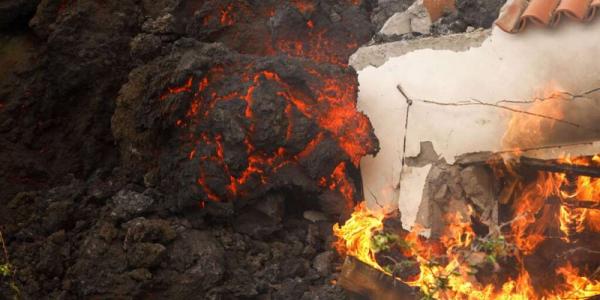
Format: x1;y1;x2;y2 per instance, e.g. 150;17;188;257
188;0;373;66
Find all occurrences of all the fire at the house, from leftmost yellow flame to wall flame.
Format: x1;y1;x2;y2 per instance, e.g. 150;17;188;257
334;88;600;300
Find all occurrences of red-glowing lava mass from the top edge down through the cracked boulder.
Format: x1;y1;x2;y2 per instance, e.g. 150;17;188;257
148;0;378;209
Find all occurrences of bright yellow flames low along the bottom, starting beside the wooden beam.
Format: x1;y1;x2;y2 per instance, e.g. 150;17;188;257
333;202;600;300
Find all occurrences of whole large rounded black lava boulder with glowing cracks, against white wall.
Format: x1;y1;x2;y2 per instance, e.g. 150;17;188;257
113;40;377;212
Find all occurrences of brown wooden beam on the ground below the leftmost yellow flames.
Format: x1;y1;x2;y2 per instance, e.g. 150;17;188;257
338;256;420;300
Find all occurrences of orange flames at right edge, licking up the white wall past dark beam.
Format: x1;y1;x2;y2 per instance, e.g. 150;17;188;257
502;82;600;246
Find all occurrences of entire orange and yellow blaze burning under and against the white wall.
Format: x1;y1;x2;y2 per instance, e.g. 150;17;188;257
333;86;600;299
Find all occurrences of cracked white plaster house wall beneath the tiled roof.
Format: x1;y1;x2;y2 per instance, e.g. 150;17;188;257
358;21;600;228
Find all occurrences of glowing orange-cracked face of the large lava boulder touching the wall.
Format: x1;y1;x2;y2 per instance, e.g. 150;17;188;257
159;59;377;209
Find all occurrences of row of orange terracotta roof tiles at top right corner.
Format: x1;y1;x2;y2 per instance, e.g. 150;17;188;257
496;0;600;33
